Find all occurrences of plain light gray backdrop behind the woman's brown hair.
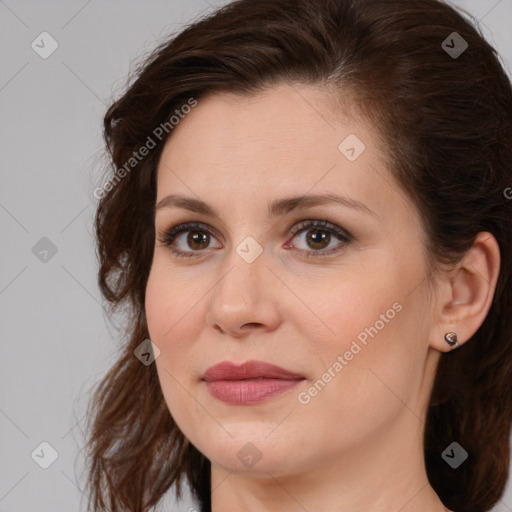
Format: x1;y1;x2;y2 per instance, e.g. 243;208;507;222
0;0;512;512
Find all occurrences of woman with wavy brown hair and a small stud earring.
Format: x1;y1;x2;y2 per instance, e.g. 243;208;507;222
84;0;512;512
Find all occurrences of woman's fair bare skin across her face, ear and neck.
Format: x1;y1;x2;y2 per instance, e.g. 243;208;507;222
146;84;499;512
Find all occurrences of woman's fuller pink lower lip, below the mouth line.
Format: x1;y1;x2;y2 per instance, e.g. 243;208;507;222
206;379;304;405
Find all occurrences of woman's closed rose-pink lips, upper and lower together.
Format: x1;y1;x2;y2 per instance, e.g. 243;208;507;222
202;361;304;405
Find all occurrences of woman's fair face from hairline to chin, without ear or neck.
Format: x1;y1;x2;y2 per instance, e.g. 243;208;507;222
146;85;439;476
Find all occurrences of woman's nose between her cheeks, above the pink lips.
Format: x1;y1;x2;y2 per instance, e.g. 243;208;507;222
206;250;282;338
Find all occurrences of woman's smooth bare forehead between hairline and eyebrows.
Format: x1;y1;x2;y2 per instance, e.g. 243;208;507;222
153;85;412;227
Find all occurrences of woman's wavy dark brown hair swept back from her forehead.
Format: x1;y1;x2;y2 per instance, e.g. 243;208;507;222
87;0;512;512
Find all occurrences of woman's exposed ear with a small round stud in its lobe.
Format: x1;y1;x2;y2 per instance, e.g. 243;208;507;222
430;232;500;352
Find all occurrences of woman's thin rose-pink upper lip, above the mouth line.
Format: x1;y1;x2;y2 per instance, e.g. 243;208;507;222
202;361;304;382
